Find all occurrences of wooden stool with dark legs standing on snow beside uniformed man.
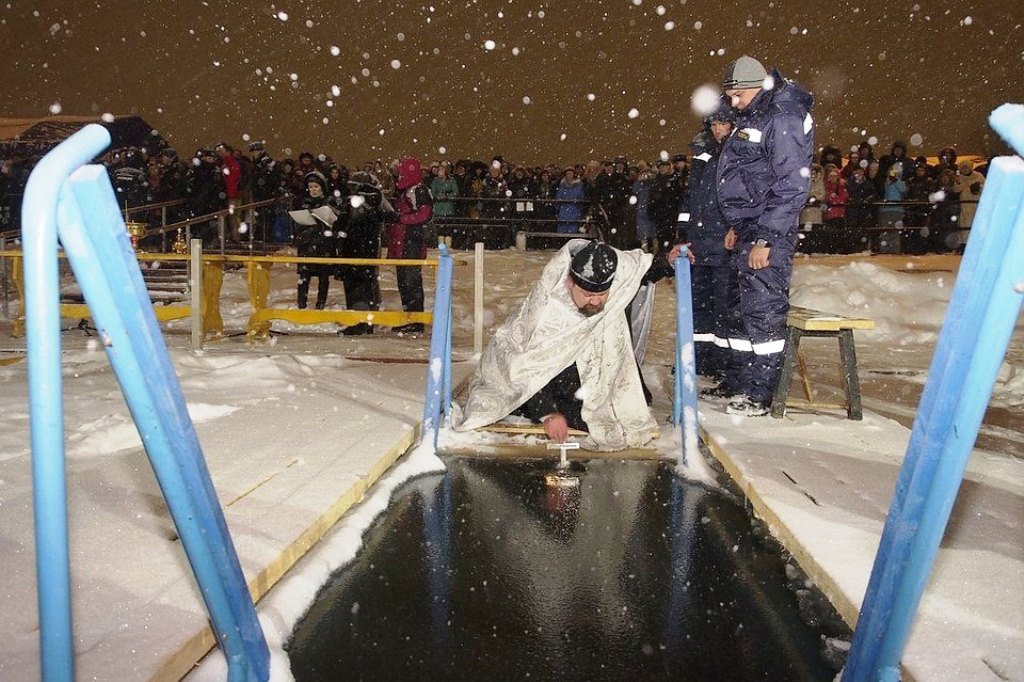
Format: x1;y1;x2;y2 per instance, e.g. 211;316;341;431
771;307;874;420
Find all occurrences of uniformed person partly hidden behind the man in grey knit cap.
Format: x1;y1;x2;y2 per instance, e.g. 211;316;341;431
683;99;738;378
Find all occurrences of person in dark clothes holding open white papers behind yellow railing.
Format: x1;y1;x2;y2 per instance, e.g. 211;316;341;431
294;171;337;310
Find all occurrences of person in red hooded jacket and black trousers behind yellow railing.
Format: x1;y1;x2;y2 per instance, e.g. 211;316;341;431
387;158;433;334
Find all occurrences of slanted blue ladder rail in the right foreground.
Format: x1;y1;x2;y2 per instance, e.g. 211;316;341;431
843;104;1024;682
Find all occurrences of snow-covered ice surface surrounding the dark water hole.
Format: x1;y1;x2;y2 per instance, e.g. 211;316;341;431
0;250;1024;680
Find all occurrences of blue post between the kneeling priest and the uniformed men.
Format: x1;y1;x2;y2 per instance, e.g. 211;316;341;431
672;246;698;466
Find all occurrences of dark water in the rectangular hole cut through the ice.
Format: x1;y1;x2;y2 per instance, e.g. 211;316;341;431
289;459;835;682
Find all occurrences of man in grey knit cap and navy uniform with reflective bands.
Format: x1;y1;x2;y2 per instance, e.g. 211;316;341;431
718;55;814;417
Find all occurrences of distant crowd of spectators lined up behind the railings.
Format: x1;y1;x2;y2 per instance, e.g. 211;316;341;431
0;135;986;253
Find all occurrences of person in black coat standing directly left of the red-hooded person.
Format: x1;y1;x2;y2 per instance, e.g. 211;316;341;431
335;171;397;336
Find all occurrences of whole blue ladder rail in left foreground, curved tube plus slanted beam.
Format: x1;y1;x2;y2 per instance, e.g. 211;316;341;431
23;125;269;682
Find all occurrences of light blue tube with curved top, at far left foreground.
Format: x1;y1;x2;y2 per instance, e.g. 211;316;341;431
22;120;111;682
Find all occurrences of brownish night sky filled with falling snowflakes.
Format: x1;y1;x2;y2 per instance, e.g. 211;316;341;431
0;0;1024;165
